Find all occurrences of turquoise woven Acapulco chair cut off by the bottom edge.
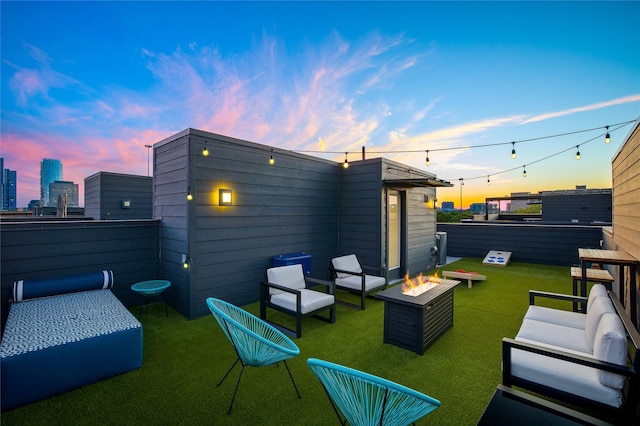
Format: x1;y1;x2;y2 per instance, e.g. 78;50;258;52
307;358;440;426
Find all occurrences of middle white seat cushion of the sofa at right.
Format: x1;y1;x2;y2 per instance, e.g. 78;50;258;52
516;319;593;356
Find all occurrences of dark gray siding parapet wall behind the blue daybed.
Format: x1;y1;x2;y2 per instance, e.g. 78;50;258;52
0;220;161;324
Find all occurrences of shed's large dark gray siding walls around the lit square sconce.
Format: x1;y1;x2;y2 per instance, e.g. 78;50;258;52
154;129;340;318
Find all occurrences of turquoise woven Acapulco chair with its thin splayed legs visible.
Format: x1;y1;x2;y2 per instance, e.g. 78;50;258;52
207;297;302;414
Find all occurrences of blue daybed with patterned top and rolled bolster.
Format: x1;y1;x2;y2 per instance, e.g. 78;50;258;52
0;271;142;411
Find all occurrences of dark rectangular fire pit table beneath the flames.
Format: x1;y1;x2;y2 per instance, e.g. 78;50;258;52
376;279;460;355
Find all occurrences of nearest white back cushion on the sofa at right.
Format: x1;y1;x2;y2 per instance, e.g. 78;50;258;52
593;313;627;389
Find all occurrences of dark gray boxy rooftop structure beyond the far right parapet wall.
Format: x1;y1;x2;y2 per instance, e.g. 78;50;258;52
542;193;612;224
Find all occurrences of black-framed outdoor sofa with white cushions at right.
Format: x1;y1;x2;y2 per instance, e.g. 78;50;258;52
502;284;640;418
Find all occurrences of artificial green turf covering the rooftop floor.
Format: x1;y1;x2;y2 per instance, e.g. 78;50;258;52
1;259;571;426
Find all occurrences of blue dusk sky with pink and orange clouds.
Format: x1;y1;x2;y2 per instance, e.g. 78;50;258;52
0;0;640;207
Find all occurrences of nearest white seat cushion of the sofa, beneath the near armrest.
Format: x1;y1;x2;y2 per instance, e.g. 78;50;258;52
511;339;622;408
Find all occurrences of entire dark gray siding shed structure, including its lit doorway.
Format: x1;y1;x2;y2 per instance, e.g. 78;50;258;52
153;129;450;318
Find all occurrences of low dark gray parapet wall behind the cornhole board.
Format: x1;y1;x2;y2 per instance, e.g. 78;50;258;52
438;223;602;266
